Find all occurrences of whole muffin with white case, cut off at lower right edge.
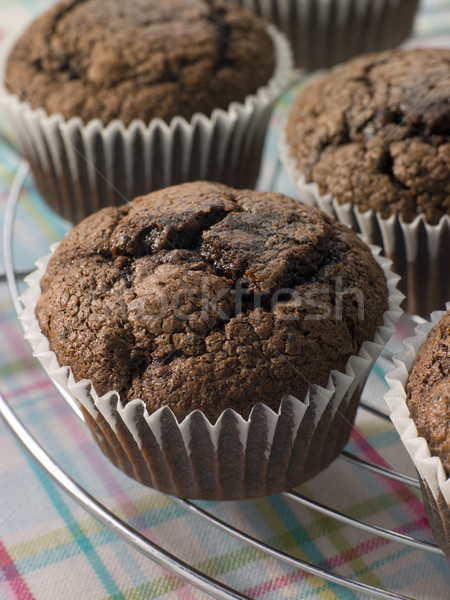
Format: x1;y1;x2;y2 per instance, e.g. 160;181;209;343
386;310;450;558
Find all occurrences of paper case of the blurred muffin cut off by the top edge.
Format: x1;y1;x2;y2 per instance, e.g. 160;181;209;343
239;0;419;71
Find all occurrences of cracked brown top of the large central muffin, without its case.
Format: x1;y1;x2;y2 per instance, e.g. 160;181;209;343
36;182;388;421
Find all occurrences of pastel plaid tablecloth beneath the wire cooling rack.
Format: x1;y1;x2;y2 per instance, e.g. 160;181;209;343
0;0;450;600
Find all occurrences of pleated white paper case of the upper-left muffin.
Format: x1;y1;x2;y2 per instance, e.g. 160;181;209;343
0;26;292;223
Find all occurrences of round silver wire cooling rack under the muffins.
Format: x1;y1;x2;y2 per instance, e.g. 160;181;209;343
0;162;445;600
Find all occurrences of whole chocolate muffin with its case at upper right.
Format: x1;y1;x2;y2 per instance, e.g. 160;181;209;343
283;48;450;318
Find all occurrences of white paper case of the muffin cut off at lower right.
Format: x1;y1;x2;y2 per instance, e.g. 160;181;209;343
385;302;450;558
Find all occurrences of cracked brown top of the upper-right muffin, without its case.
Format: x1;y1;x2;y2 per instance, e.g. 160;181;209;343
286;48;450;224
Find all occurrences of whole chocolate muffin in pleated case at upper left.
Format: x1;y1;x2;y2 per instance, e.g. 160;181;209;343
0;0;292;224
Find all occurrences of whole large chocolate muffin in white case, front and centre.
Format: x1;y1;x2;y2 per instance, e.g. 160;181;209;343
21;182;402;500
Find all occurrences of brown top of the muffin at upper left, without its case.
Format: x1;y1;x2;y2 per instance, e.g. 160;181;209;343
7;0;275;124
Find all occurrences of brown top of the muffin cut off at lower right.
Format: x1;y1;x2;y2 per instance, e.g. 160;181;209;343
406;310;450;477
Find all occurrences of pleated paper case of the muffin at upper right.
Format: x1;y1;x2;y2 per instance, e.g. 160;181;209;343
280;139;450;318
